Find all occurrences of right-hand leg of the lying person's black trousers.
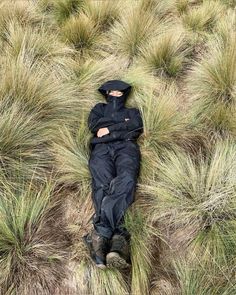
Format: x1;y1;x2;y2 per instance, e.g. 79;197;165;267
99;142;141;237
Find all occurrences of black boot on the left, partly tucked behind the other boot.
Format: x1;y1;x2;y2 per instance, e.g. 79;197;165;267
83;229;110;269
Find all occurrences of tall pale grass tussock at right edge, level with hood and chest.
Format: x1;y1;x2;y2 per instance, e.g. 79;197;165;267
187;33;236;141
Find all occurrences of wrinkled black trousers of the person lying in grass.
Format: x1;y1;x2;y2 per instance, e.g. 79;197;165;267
89;140;141;239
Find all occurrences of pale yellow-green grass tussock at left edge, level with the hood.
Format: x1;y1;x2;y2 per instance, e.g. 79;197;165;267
0;53;78;126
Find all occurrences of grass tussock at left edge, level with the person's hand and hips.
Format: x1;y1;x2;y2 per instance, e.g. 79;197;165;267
0;102;52;185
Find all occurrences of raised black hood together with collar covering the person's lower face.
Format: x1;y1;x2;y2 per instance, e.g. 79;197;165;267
98;80;131;114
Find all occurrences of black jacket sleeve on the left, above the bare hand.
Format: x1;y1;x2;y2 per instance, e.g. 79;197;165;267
88;103;114;134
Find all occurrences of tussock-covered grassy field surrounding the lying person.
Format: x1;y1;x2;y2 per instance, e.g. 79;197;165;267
0;0;236;295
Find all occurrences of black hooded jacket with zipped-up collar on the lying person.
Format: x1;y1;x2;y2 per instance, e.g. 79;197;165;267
88;80;143;148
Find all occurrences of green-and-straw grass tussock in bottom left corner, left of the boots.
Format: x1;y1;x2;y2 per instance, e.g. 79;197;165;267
0;177;68;294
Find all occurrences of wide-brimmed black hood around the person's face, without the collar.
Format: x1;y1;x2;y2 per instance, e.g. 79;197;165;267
98;80;132;104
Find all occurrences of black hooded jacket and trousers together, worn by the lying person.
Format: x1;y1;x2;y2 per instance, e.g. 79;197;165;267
88;80;143;238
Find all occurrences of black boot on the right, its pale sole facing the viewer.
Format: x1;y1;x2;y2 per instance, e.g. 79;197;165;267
106;234;131;269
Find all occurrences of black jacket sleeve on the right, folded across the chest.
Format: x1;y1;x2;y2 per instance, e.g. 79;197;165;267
108;108;143;132
